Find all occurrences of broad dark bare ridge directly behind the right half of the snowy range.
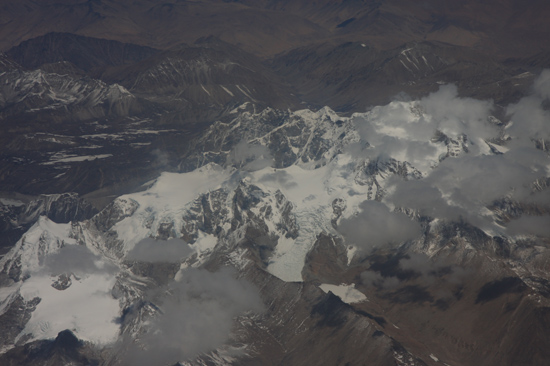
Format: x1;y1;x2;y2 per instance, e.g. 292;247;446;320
273;41;530;108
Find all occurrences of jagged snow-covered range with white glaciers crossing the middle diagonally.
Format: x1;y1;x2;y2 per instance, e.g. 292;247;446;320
0;78;548;364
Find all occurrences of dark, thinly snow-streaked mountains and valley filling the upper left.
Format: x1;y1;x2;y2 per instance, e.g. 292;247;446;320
0;33;298;194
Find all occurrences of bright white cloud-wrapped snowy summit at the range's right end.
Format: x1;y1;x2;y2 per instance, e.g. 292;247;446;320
354;85;499;172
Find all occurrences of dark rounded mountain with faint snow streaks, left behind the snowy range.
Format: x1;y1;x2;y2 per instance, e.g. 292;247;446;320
113;37;302;110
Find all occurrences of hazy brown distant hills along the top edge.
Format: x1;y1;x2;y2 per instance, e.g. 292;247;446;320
0;0;549;57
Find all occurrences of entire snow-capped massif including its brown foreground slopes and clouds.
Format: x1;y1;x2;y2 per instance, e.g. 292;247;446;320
0;74;550;365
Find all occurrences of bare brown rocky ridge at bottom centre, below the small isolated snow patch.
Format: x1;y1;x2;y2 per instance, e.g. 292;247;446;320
203;246;424;366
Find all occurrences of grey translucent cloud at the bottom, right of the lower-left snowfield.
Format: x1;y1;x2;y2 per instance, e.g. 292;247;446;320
126;268;263;366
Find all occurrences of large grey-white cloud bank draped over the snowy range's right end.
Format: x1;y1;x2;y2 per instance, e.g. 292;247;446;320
356;70;550;232
